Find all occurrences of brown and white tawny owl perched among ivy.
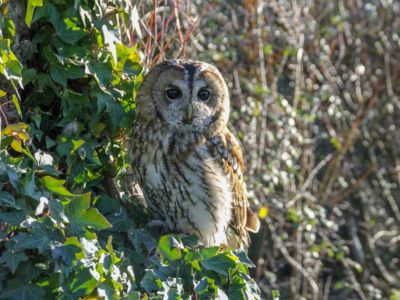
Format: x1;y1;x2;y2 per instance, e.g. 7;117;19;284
130;60;260;248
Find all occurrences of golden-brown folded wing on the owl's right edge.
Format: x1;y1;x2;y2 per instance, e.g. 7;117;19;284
211;129;260;244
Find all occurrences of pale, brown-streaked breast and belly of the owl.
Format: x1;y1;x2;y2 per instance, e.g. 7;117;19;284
134;130;232;245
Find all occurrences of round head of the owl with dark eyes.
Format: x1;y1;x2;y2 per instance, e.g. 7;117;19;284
137;60;230;131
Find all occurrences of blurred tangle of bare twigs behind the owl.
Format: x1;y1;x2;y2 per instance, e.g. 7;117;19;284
133;0;400;299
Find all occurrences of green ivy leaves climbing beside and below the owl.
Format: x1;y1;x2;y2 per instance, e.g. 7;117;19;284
0;0;259;299
